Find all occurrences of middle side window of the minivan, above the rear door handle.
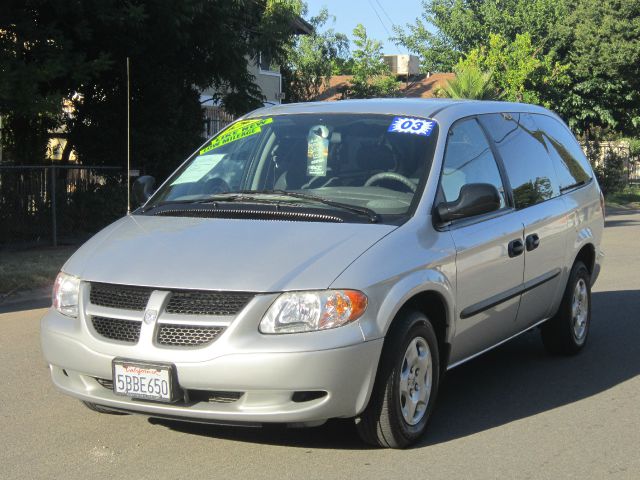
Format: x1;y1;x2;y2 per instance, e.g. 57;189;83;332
480;113;560;209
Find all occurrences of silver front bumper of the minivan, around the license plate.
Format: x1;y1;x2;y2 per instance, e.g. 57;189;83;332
41;310;383;424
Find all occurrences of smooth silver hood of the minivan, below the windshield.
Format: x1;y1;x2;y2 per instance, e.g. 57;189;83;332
63;215;397;292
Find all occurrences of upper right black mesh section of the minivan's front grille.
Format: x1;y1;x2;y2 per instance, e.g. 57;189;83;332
166;290;253;315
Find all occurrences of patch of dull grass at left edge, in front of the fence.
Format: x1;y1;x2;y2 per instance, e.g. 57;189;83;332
0;247;77;297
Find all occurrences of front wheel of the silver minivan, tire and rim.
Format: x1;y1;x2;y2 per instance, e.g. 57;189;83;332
356;311;440;448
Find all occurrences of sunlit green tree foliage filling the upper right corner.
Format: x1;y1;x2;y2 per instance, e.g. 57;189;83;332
395;0;640;140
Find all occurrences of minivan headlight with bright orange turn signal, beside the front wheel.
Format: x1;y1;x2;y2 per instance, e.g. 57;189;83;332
260;290;367;333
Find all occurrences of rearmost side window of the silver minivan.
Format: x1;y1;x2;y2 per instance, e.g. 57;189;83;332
533;115;591;190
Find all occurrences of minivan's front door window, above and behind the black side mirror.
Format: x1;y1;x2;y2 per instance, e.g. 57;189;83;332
440;119;505;208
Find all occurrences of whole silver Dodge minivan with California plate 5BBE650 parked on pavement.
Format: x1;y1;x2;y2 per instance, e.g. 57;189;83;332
41;99;604;448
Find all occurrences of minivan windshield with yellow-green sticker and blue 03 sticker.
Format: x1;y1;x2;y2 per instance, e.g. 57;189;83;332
145;114;437;222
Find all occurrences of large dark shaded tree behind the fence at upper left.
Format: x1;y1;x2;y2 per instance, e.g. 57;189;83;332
0;0;301;176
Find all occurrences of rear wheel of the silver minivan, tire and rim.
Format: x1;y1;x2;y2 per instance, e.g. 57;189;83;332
540;260;591;355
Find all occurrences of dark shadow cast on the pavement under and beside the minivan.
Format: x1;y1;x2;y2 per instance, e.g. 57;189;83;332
150;290;640;449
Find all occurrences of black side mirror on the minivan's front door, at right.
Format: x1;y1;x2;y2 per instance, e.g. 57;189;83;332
436;183;500;222
